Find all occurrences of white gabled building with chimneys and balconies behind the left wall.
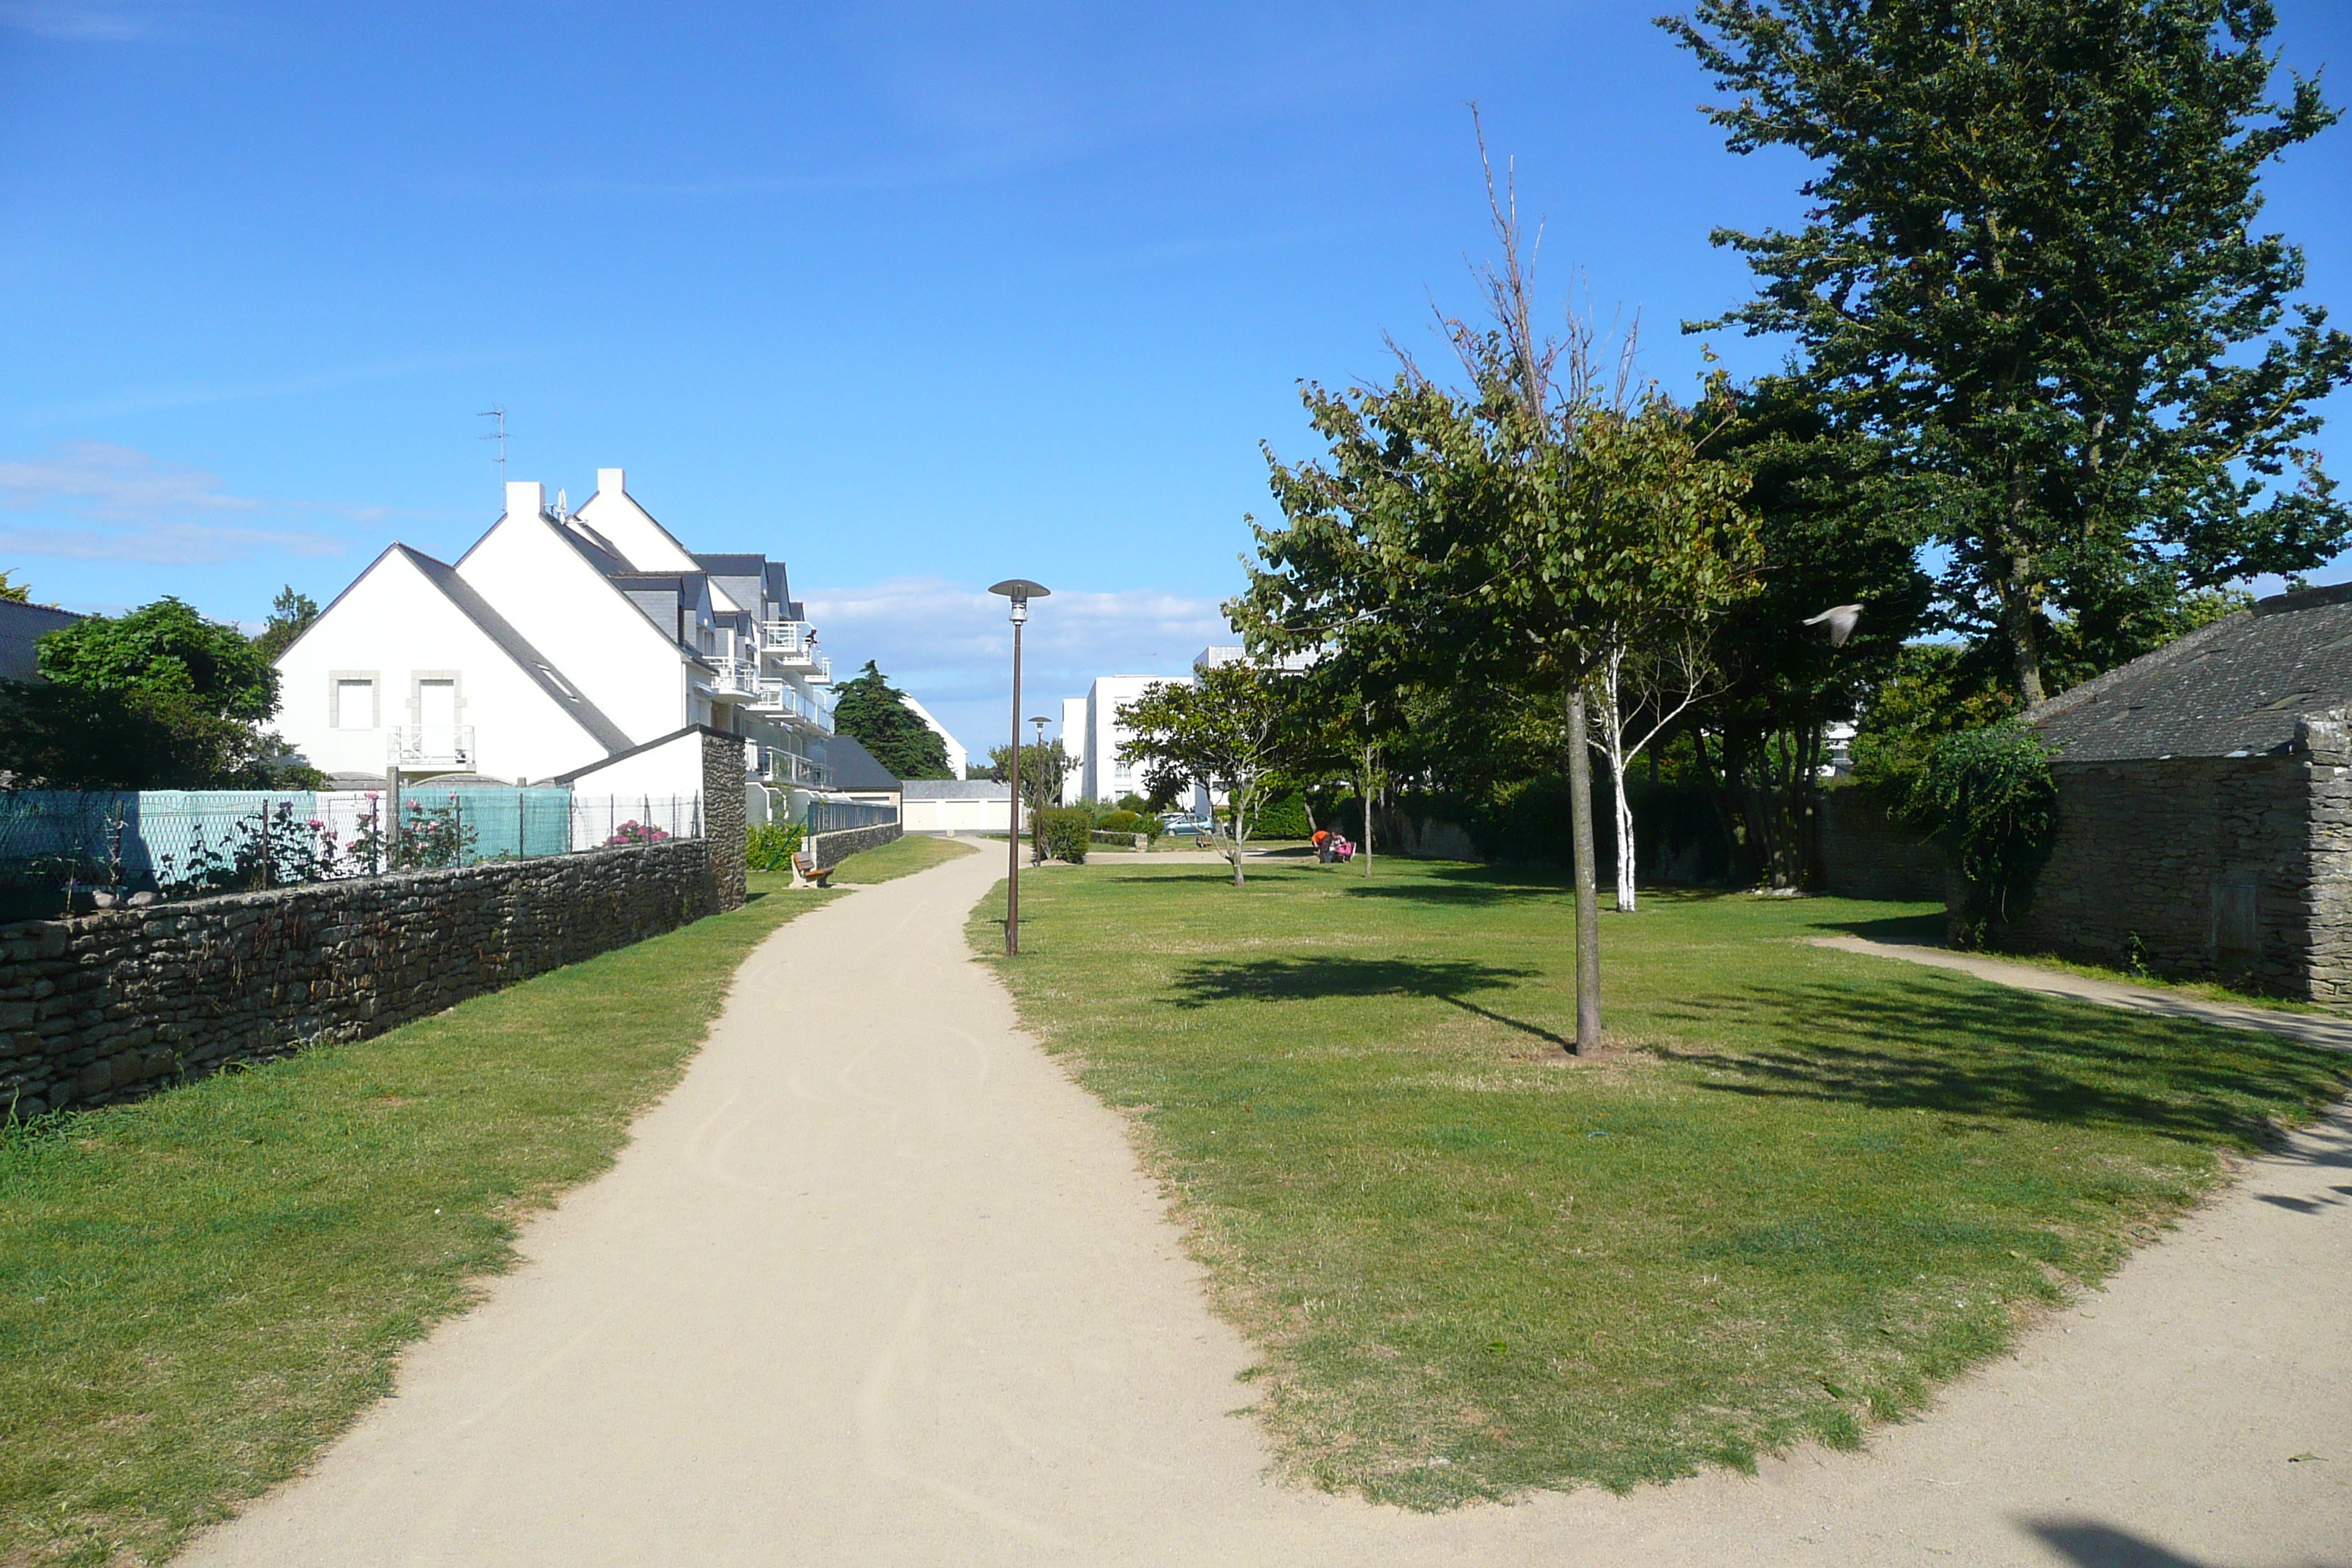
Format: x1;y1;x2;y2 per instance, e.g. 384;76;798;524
277;468;832;794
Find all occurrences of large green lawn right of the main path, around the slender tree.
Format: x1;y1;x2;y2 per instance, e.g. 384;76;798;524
971;860;2352;1507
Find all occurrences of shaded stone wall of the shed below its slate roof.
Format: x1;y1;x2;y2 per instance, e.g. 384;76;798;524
1999;753;2323;999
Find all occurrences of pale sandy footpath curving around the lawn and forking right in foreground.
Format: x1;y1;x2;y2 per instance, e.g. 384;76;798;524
186;856;2352;1568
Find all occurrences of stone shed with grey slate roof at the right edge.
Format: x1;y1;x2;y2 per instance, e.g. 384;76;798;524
2002;585;2352;1001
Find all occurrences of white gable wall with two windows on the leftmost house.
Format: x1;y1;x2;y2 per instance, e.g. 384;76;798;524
277;548;605;778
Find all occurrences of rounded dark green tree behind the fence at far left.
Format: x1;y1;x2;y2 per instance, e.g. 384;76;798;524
0;600;298;790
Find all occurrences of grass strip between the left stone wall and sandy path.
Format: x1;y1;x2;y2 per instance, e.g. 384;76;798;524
0;893;837;1564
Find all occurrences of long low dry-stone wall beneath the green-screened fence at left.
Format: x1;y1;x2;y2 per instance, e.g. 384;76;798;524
0;841;743;1119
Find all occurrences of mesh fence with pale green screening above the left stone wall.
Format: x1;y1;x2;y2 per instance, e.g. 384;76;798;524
0;785;704;921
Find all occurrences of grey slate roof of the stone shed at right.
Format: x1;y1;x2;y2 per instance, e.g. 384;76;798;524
2025;583;2352;761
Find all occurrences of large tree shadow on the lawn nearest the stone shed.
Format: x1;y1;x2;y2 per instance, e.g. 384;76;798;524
1651;976;2348;1142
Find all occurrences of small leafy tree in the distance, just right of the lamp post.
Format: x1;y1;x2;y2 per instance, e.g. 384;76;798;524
1120;663;1296;886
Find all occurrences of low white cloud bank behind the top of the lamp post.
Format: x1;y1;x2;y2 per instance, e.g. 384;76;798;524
799;578;1232;755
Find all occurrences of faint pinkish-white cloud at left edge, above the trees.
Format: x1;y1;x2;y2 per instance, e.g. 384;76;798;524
0;442;344;567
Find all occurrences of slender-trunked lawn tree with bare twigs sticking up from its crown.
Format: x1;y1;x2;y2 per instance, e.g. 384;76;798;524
1242;137;1741;1051
